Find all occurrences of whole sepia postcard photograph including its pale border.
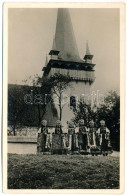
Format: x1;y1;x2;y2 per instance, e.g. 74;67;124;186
3;3;125;194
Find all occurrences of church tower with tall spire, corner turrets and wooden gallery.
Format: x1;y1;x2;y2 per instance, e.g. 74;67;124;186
42;8;95;126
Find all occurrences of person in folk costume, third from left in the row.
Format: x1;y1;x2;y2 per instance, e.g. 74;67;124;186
68;121;76;151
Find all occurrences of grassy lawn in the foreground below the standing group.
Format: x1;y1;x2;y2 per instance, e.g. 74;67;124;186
8;154;119;189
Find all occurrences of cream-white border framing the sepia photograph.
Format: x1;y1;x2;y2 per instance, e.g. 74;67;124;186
3;1;125;194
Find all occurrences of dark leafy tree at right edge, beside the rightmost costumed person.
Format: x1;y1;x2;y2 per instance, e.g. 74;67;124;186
97;91;120;150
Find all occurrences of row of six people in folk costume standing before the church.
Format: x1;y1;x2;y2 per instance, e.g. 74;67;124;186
38;119;112;155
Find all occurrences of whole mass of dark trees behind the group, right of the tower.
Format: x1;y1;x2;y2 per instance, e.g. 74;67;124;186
73;91;120;150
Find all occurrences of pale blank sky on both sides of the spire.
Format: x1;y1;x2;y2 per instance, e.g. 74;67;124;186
8;8;120;93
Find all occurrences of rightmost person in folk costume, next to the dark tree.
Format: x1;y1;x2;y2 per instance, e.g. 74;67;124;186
97;120;110;155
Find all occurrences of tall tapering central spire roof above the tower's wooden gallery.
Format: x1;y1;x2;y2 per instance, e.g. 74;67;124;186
55;8;81;62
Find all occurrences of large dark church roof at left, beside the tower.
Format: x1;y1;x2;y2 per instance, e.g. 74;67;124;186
8;82;46;136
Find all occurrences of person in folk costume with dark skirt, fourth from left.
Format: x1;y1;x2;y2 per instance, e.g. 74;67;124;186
79;119;90;152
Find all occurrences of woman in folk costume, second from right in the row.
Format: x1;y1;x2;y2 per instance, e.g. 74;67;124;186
88;120;97;147
